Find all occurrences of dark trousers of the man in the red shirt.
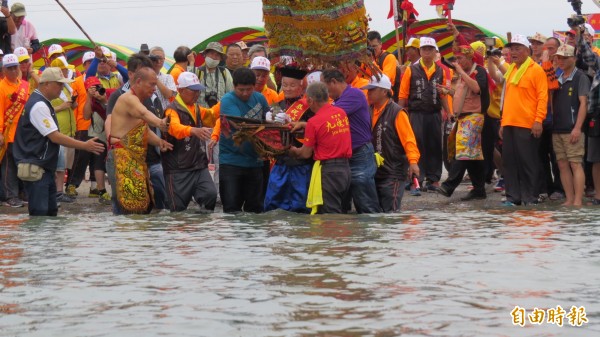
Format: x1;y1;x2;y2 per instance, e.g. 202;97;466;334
318;159;352;214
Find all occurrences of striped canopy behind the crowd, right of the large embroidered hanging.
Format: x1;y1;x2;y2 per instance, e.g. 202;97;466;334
381;19;506;57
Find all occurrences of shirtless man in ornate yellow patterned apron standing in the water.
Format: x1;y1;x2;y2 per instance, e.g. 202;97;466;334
106;67;173;214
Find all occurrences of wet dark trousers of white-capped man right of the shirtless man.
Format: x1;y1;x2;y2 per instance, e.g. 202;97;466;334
165;168;217;212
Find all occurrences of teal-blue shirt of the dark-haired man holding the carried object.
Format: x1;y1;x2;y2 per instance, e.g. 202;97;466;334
219;91;269;167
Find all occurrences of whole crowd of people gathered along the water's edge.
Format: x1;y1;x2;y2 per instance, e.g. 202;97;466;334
0;3;600;215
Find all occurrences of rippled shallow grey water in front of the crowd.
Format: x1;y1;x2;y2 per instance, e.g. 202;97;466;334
0;209;600;337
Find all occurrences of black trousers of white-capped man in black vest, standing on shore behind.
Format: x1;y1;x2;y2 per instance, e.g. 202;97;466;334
409;112;443;182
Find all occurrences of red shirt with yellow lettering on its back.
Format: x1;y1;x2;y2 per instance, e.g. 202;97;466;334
304;104;352;160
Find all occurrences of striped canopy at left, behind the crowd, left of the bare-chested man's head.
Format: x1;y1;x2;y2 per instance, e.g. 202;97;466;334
33;39;175;73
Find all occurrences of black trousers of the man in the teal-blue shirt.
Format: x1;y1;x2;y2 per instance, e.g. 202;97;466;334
219;164;264;213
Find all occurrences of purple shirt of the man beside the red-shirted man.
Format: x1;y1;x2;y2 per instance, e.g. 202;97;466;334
333;85;372;150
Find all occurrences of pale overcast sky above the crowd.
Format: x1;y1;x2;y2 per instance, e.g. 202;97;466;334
16;0;600;55
